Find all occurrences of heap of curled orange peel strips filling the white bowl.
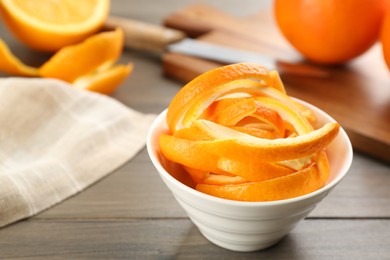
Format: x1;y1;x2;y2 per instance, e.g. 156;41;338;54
159;63;340;201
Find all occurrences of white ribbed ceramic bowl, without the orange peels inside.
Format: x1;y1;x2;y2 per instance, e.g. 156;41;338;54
147;100;353;251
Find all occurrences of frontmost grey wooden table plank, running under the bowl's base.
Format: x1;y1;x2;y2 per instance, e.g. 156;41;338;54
0;219;390;259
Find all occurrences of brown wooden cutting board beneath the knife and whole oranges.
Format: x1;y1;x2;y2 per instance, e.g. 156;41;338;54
163;4;390;162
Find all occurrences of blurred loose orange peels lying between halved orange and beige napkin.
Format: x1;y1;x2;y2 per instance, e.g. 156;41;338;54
0;28;133;94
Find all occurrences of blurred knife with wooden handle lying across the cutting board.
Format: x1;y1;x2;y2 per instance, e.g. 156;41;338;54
105;16;329;77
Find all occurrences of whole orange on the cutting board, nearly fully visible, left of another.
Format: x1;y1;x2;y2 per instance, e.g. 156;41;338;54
274;0;386;64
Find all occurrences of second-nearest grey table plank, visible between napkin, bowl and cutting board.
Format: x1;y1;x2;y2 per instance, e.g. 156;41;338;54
35;150;390;219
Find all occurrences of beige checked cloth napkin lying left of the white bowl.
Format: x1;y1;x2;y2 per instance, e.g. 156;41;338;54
0;78;155;227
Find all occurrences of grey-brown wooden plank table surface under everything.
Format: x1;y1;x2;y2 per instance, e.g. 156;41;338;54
0;0;390;259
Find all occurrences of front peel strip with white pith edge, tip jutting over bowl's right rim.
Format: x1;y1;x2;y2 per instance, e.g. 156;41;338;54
195;119;339;162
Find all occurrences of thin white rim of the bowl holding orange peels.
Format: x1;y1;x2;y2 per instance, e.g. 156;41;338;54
146;98;353;207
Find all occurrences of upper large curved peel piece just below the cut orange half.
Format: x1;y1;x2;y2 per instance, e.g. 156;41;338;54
39;28;123;82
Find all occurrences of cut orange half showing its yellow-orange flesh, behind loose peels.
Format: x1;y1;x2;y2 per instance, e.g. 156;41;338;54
0;0;110;52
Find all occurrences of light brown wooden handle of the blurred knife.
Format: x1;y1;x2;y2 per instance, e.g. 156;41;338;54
104;16;185;52
